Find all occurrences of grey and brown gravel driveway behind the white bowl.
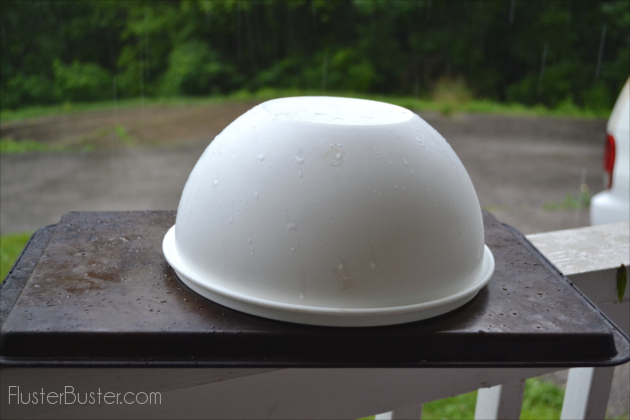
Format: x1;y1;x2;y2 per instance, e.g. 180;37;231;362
0;103;605;233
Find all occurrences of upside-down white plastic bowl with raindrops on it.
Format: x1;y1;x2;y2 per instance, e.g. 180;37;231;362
163;97;494;326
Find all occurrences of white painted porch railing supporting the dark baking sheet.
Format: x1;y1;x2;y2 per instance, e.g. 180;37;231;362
1;223;630;419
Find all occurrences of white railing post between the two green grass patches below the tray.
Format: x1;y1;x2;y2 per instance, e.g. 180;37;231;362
475;379;525;420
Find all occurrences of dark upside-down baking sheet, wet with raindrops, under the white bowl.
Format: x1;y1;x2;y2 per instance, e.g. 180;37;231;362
1;211;630;367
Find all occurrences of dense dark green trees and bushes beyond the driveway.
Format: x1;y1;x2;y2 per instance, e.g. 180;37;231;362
0;0;630;109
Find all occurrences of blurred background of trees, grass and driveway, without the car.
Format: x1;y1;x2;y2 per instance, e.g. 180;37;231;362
0;0;630;419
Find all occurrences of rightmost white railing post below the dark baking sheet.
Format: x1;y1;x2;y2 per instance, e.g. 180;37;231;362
560;367;615;420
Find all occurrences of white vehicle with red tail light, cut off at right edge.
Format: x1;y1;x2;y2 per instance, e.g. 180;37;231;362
591;78;630;225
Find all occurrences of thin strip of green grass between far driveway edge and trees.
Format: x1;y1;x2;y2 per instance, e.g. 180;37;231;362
0;88;610;123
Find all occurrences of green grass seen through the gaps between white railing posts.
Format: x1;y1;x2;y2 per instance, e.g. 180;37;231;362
361;378;628;420
